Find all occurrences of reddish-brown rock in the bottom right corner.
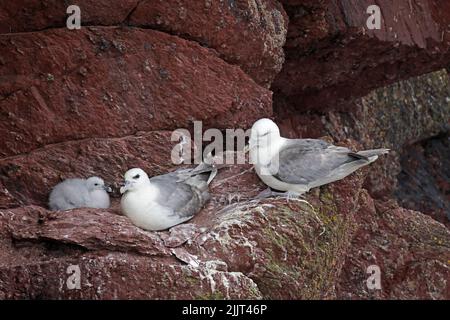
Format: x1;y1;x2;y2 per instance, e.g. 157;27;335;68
337;194;450;299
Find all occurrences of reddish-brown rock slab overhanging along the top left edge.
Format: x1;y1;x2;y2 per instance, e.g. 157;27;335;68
0;0;288;87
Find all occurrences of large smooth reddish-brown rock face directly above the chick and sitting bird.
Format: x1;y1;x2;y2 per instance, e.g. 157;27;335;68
0;28;271;156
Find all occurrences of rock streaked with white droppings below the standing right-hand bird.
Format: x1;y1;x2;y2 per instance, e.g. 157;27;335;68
188;170;362;299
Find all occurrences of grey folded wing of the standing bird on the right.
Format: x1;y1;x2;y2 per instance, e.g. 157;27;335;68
273;139;355;185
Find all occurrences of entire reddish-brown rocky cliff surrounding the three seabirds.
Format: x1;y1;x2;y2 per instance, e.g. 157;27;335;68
0;0;450;299
